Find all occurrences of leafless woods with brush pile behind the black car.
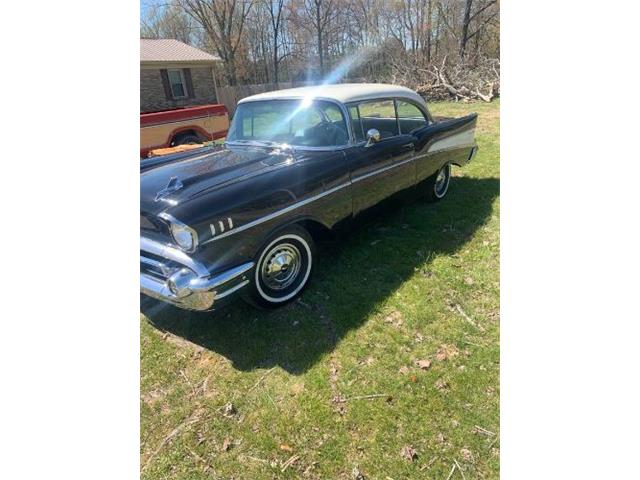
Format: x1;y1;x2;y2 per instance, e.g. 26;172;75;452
140;0;500;101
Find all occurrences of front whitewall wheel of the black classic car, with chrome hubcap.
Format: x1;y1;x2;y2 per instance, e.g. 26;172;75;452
250;226;315;308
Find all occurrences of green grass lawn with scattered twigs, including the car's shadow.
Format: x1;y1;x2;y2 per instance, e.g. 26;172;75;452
140;102;500;480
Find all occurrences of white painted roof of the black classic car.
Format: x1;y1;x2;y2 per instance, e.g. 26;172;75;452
238;83;426;106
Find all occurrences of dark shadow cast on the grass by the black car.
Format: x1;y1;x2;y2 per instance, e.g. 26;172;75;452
141;177;500;375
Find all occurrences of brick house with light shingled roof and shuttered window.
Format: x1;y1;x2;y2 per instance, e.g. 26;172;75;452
140;38;219;112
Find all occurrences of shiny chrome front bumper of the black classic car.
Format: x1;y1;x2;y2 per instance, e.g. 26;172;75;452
140;237;254;311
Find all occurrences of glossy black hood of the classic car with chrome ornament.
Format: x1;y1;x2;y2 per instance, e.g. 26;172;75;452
140;146;294;216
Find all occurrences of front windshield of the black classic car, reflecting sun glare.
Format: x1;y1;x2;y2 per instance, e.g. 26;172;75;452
227;100;349;147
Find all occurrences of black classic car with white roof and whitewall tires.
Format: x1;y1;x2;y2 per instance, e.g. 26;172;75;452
140;84;477;310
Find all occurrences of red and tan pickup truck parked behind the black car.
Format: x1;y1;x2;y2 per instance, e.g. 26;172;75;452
140;104;229;158
